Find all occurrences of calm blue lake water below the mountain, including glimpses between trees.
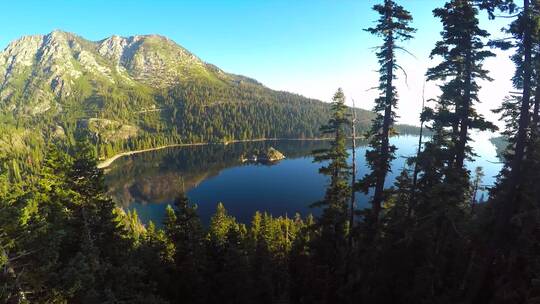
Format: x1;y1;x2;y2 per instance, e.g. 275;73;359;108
106;133;501;224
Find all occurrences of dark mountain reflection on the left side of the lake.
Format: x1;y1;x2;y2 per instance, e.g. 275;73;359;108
105;140;328;220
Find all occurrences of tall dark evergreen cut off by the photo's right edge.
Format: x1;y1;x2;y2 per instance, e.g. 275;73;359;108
470;0;540;302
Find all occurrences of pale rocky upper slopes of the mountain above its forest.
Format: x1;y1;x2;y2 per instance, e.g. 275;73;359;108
0;31;228;115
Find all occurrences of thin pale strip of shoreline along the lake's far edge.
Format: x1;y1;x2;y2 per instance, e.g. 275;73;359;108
97;138;332;169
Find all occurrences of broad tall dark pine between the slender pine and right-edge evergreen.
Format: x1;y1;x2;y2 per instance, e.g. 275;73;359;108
375;0;493;302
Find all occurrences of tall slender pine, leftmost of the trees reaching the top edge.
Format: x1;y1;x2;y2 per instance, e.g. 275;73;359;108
361;0;415;229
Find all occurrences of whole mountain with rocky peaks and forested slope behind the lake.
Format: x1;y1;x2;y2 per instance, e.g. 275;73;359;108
0;31;414;173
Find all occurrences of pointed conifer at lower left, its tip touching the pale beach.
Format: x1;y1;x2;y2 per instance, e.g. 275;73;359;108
63;140;159;303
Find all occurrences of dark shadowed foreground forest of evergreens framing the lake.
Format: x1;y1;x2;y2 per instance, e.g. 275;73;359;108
0;0;540;304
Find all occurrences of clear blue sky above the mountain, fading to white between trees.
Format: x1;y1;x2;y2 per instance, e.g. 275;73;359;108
0;0;514;124
